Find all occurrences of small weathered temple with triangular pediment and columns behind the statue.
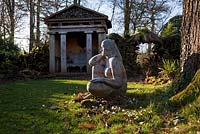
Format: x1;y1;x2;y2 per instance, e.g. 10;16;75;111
45;4;112;73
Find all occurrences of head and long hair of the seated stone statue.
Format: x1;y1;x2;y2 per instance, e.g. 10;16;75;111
101;39;122;60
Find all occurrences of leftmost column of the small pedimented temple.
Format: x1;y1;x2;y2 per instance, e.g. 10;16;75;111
49;33;56;73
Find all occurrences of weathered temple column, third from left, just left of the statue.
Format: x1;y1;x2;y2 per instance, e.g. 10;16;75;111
86;32;92;73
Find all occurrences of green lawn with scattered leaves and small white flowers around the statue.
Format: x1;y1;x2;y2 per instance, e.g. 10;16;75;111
0;80;200;134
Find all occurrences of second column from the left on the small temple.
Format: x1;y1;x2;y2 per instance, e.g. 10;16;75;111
60;33;67;73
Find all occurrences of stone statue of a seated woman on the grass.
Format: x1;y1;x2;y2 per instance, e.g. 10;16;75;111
87;39;127;98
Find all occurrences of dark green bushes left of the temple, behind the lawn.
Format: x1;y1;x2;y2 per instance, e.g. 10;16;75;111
0;38;49;79
